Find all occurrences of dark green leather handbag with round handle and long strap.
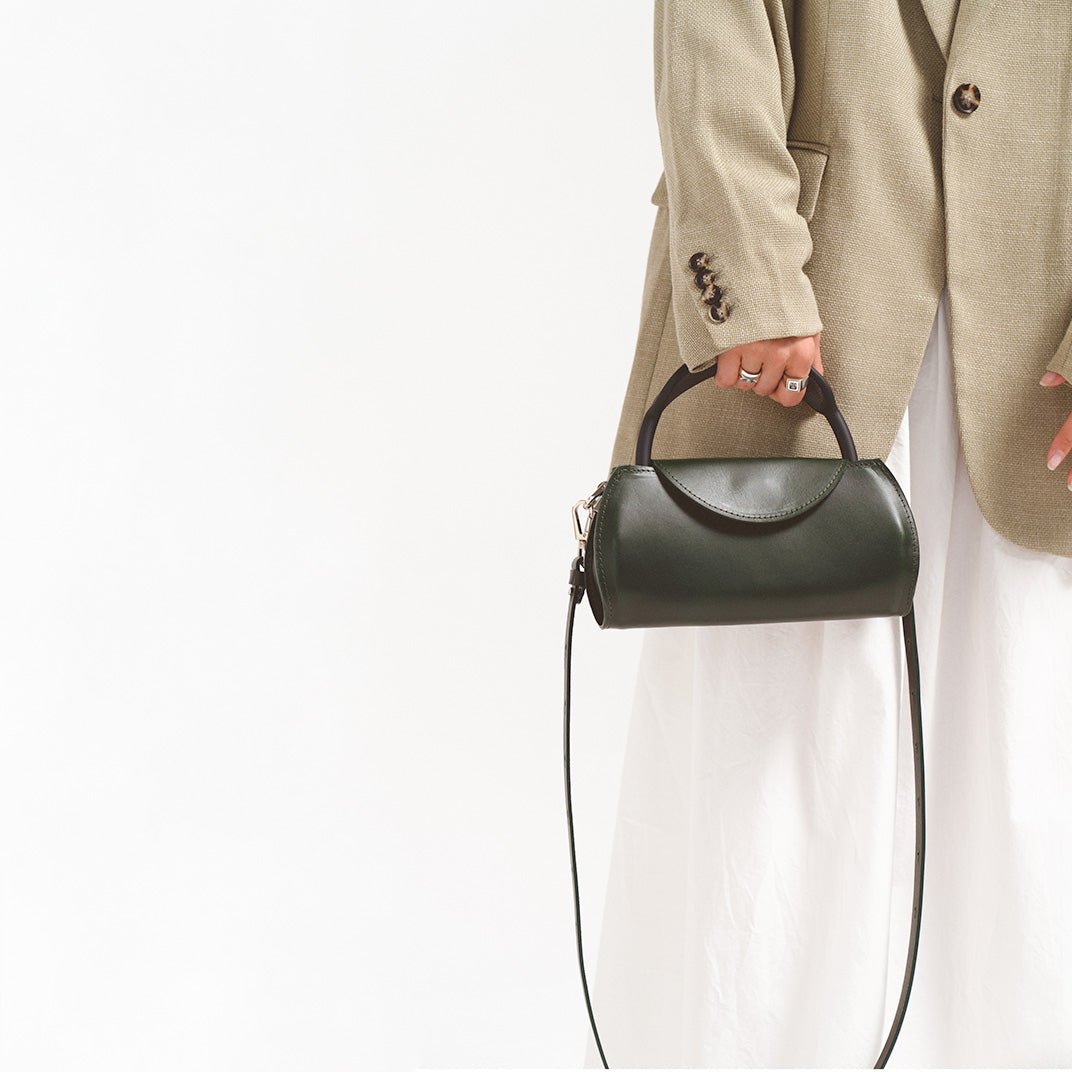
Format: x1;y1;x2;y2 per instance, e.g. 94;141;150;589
564;366;925;1068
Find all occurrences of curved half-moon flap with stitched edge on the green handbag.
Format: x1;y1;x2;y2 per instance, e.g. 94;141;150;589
652;458;846;521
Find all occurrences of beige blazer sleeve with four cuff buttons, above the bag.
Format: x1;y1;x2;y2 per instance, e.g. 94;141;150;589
655;0;822;370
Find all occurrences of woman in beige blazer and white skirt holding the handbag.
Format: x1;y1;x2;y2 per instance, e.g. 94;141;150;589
595;0;1072;1067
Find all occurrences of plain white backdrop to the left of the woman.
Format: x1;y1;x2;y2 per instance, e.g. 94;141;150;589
0;0;659;1072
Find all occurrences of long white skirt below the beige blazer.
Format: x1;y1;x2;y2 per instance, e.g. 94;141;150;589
589;293;1072;1068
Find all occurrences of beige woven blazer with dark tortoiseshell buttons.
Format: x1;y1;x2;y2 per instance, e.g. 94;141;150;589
613;0;1072;556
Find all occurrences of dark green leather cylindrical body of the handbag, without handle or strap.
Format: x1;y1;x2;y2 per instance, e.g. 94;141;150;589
585;458;919;628
